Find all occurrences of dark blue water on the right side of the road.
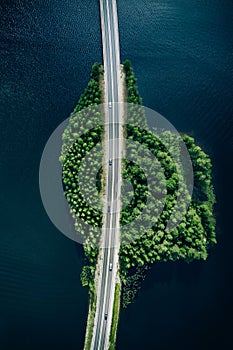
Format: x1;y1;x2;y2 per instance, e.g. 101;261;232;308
117;0;233;350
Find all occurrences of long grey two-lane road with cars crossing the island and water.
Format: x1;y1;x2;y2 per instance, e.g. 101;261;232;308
91;0;123;350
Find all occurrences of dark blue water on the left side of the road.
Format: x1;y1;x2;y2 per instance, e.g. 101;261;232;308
0;0;101;350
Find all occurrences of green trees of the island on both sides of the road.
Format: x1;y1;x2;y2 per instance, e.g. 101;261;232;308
60;60;216;342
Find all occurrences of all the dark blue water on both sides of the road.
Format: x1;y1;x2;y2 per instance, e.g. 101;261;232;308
0;0;233;350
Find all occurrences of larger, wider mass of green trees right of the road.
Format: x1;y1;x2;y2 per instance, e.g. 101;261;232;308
120;60;216;307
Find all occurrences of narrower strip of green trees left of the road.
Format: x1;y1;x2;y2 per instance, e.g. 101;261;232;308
60;63;103;298
